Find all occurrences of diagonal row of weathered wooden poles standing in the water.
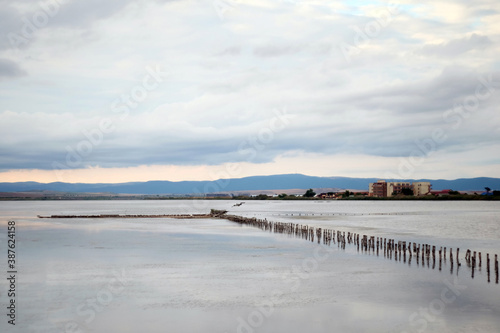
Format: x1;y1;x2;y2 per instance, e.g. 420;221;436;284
223;214;499;284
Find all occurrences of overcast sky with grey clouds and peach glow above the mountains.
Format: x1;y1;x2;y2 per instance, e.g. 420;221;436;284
0;0;500;183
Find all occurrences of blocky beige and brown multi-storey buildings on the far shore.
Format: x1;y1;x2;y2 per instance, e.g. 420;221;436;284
368;180;431;198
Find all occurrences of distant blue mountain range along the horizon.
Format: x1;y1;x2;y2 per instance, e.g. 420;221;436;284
0;174;500;194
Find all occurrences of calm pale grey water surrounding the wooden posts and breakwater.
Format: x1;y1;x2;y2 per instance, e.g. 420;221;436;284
0;201;500;333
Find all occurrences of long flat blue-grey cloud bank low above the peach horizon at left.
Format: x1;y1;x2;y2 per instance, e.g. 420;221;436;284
0;134;275;170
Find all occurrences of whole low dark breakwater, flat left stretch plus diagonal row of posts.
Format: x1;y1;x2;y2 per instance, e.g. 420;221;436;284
38;209;499;284
